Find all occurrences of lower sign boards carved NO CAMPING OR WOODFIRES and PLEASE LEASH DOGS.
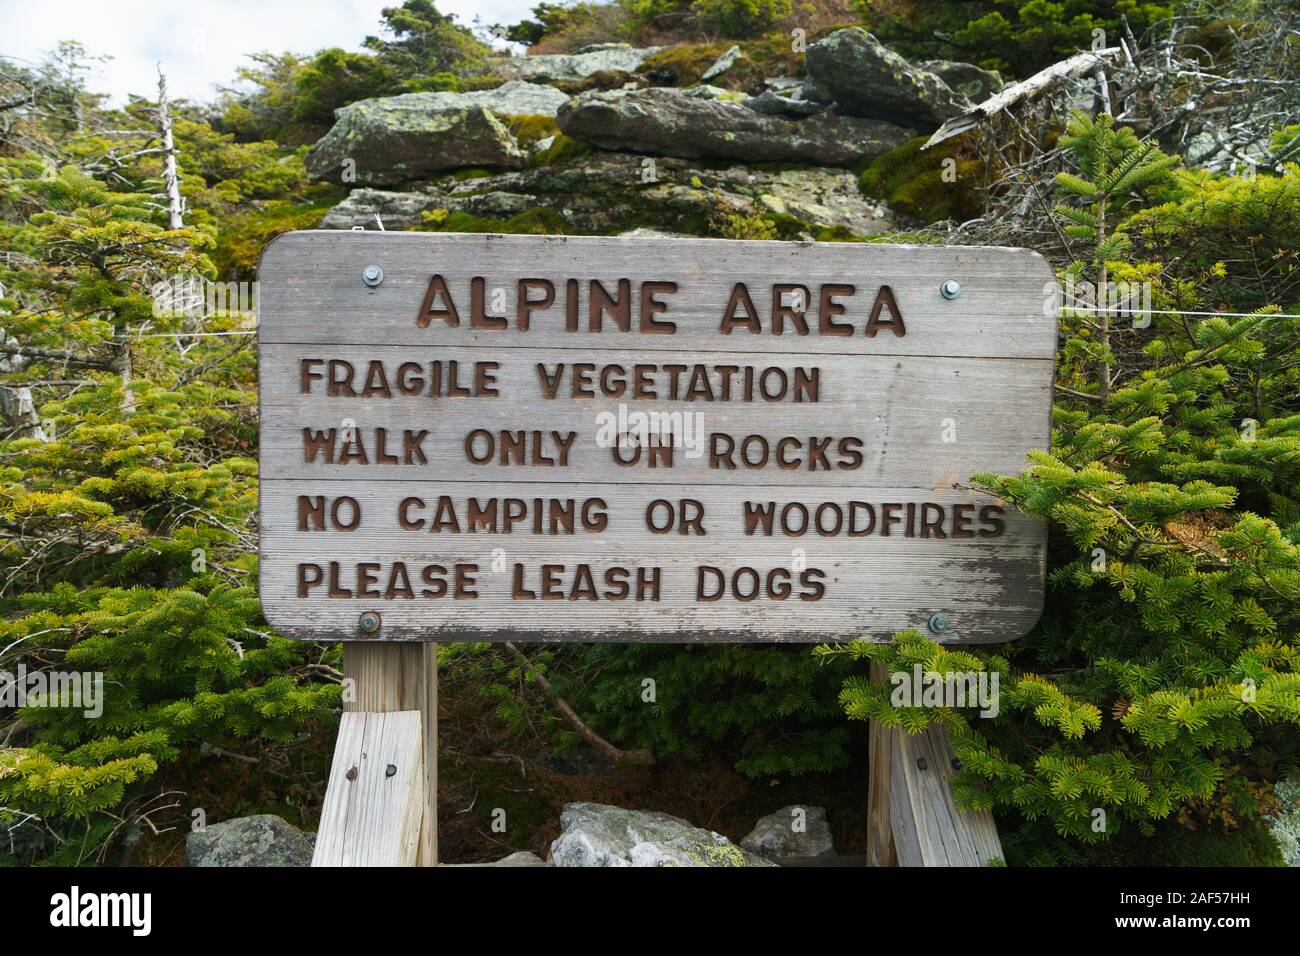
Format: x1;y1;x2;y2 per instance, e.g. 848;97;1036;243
260;481;1044;643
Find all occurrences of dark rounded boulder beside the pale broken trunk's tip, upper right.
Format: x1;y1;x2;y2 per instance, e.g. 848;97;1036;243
806;27;962;126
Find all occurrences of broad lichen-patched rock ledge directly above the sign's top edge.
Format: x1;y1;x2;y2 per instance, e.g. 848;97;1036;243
322;152;893;238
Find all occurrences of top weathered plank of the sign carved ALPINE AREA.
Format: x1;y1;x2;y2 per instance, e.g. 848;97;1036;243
257;230;1057;359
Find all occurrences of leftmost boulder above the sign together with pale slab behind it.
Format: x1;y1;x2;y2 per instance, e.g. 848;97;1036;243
307;81;568;186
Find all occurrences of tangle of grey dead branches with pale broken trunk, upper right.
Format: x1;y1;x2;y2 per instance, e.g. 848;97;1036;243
904;0;1300;261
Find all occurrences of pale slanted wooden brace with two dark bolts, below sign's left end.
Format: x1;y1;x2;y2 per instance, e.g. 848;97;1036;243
312;710;424;866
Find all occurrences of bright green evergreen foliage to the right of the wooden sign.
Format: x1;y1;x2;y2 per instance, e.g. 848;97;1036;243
819;120;1300;862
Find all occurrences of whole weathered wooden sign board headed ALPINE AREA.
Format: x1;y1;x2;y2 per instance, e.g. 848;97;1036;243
259;232;1056;643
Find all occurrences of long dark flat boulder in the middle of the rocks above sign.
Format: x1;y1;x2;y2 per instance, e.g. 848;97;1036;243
555;87;917;165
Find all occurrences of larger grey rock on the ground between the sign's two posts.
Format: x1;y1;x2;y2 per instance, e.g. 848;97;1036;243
551;803;774;866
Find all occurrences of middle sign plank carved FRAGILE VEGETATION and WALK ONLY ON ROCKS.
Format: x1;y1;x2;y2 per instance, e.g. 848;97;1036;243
261;346;1052;488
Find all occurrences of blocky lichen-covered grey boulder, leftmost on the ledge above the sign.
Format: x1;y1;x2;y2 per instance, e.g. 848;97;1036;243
306;103;524;186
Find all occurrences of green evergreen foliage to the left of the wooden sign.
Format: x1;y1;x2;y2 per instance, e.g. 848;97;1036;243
0;69;338;862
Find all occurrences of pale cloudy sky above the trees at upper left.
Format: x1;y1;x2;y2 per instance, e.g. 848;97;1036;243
0;0;537;103
